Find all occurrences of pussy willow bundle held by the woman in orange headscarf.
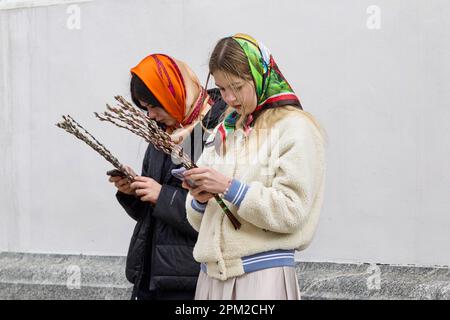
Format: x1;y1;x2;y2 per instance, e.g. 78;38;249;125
56;115;134;182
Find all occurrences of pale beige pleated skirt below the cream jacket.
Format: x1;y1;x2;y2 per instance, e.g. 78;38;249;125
195;267;301;300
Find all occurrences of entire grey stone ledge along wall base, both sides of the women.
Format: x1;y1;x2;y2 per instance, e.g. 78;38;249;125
0;252;450;300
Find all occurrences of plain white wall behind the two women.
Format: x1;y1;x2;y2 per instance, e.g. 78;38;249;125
0;0;450;265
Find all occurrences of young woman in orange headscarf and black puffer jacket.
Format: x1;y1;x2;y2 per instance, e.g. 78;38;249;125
110;54;226;300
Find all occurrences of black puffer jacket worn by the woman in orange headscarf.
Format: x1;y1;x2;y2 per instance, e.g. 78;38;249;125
116;90;226;299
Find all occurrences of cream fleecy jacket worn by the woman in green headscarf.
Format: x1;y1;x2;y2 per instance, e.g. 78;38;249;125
186;112;325;280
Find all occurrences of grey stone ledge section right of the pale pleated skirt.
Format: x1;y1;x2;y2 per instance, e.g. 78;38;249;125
297;262;450;300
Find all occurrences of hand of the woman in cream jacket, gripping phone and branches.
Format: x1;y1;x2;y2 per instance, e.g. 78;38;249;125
183;167;232;195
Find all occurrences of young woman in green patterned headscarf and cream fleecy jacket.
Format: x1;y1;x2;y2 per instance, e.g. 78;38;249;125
183;34;325;299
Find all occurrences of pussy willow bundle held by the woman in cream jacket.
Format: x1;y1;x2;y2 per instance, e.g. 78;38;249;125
95;96;241;229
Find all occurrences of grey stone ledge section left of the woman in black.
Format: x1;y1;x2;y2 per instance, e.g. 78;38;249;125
0;252;132;300
